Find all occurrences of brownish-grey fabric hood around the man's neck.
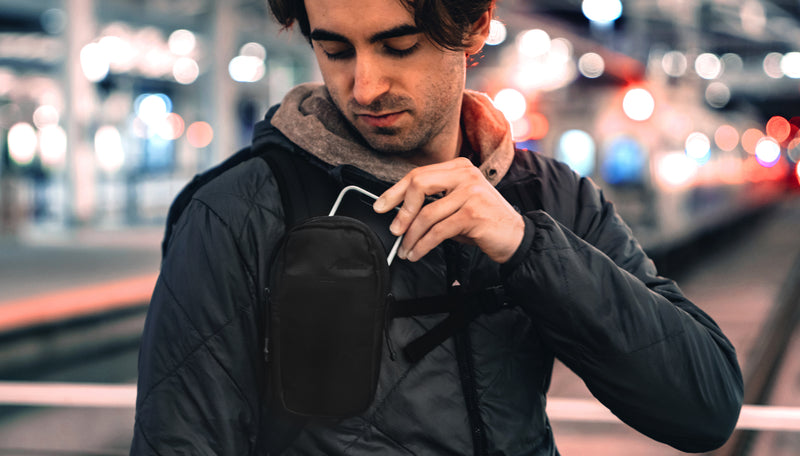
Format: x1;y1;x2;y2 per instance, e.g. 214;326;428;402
271;83;514;185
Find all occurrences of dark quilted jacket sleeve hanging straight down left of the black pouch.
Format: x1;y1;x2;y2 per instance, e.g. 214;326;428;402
130;160;283;455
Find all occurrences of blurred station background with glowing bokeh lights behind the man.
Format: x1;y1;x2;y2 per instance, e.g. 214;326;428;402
0;0;800;456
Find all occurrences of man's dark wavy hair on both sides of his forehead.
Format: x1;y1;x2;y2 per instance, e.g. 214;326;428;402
269;0;495;50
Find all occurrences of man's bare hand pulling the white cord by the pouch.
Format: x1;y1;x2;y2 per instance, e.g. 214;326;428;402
374;158;525;263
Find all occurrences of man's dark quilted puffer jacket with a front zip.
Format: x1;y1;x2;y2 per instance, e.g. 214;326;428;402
131;108;742;456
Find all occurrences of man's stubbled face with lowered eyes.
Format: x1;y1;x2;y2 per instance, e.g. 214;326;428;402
305;0;466;161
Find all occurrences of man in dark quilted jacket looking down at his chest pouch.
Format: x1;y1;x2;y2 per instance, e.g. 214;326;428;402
131;0;742;455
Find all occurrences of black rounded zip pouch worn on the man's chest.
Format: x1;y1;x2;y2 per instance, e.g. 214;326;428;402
268;188;390;418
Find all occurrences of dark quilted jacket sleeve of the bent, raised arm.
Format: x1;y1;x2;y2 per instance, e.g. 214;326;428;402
503;175;743;452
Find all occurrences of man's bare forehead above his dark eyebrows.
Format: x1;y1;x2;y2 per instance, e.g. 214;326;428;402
305;0;414;38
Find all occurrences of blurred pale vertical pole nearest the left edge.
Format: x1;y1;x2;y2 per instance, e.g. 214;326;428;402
63;0;96;226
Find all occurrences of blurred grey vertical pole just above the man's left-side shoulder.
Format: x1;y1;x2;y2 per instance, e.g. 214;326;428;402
209;0;239;167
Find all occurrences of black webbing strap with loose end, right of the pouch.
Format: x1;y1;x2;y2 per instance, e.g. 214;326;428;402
389;285;509;363
